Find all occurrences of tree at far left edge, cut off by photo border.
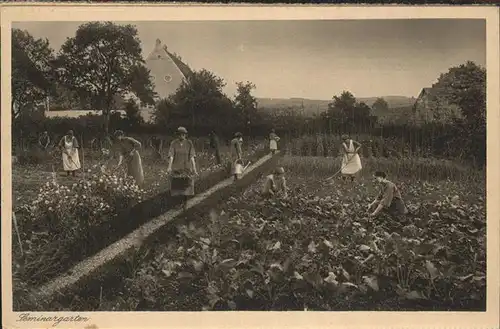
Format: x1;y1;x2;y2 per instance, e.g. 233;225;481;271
11;29;54;119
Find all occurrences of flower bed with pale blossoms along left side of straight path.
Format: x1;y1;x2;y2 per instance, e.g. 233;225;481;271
13;142;267;286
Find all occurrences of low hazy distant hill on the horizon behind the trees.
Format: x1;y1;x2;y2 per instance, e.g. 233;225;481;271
257;96;416;115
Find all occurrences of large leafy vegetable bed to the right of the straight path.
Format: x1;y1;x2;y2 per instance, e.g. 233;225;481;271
21;156;486;311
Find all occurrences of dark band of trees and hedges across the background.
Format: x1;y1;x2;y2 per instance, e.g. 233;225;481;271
12;22;486;165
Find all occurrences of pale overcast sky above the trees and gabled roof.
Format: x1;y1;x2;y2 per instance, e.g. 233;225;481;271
12;19;486;100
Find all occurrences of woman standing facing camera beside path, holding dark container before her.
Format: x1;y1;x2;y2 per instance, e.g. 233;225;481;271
167;127;198;210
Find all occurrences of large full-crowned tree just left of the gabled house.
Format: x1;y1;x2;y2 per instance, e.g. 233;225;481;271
57;22;156;133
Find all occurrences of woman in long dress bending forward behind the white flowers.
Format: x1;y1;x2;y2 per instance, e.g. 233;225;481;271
113;130;144;186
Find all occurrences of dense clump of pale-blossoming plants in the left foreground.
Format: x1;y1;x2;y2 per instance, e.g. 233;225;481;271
16;168;145;240
